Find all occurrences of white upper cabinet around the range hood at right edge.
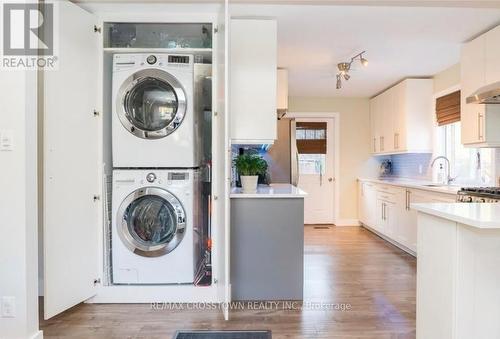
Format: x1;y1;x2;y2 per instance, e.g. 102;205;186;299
460;26;500;147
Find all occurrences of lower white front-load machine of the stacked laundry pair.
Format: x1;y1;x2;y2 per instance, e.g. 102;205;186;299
111;169;200;284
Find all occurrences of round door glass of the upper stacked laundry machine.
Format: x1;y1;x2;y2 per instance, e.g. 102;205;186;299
123;77;179;132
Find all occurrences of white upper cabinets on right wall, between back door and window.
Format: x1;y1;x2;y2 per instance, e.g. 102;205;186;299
370;79;433;154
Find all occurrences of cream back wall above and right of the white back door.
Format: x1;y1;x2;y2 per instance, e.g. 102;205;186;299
289;97;378;222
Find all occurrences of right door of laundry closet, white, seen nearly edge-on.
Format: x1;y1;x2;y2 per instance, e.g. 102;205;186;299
212;0;231;320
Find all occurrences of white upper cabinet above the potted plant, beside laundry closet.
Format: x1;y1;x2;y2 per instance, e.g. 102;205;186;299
229;19;277;144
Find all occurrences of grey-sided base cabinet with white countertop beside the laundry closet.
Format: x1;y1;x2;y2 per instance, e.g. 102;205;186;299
230;184;306;300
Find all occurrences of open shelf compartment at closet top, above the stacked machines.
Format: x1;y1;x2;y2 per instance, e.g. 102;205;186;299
103;22;212;50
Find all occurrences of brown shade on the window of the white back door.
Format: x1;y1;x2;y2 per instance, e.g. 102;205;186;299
296;122;326;154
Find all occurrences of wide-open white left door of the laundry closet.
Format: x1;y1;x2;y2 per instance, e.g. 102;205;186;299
41;1;101;319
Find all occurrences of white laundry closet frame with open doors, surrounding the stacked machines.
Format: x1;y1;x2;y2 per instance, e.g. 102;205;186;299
40;0;232;318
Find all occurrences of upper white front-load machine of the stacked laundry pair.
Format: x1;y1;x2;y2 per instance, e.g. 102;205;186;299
112;54;201;168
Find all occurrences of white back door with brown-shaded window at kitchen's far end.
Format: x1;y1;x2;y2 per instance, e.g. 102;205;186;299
296;118;336;224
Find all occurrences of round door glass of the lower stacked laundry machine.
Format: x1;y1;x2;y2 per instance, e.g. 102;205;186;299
124;195;177;246
